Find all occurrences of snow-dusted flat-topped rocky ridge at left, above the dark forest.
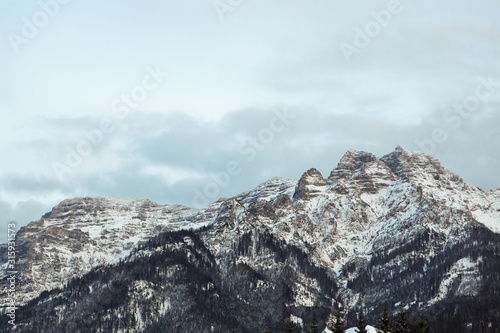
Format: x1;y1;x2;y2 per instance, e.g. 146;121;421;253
0;197;217;304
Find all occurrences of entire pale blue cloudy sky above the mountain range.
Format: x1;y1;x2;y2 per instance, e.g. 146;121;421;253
0;0;500;242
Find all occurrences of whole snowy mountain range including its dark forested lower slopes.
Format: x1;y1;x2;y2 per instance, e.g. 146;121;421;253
0;146;500;332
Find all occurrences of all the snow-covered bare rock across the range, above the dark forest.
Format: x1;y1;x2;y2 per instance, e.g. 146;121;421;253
0;146;500;320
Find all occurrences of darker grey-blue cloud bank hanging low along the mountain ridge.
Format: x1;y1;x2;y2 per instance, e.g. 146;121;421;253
0;104;500;239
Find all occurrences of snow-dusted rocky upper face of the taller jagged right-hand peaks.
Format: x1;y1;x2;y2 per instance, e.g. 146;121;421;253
197;147;499;307
